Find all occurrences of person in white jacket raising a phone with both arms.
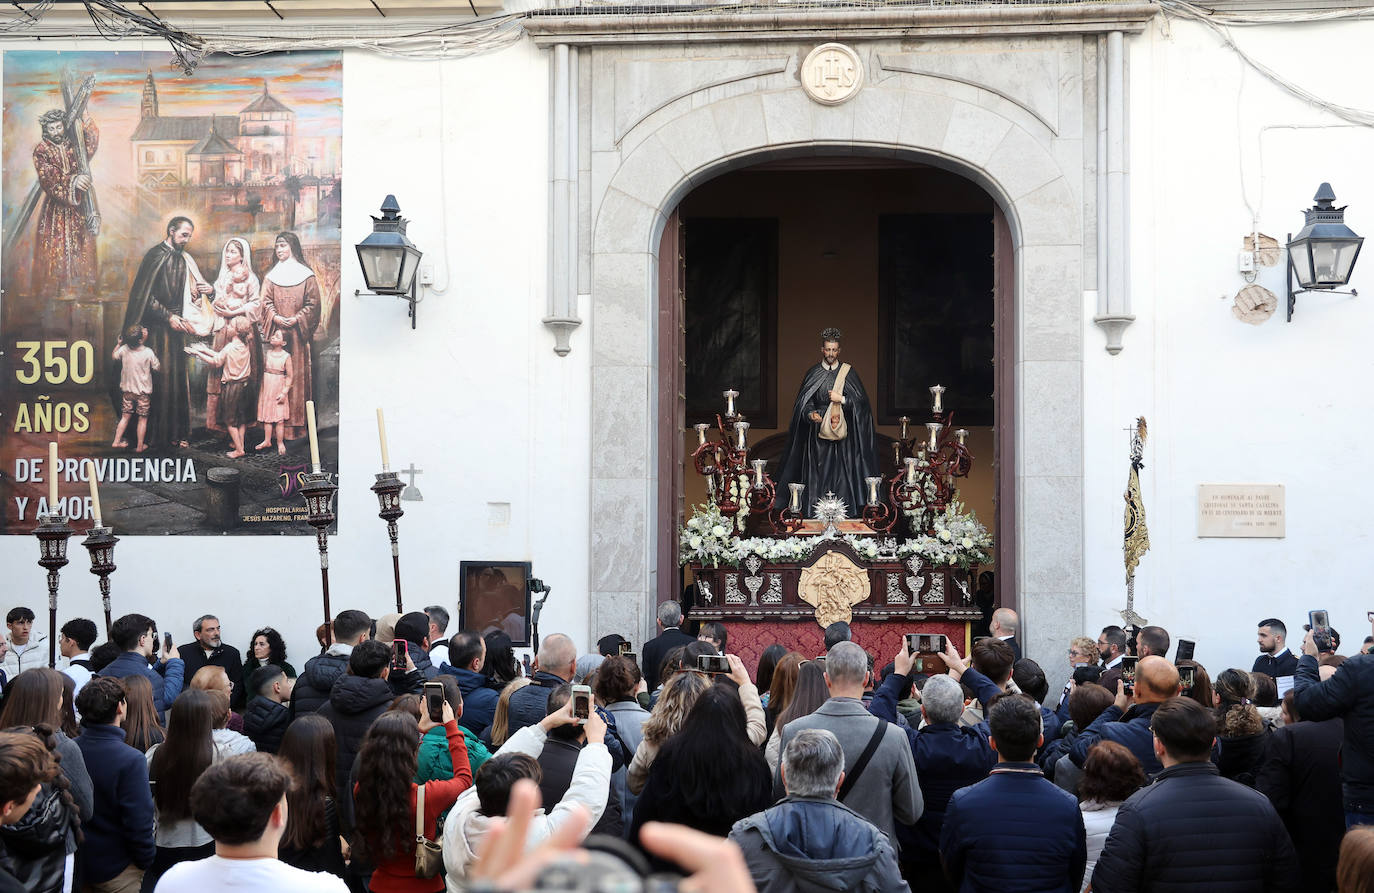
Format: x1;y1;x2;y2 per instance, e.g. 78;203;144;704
444;692;610;893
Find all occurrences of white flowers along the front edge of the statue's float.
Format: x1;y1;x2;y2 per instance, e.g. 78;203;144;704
677;500;992;569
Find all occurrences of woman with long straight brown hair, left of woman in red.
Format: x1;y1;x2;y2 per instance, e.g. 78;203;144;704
276;713;344;878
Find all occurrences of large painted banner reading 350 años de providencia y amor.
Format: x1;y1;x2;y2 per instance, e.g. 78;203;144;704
0;52;342;534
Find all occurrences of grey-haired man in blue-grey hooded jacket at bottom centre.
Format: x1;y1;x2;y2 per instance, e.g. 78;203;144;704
730;730;910;893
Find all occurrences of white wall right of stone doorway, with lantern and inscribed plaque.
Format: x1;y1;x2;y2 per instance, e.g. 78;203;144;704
1082;19;1374;676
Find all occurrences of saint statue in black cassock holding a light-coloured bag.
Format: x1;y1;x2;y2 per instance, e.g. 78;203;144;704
774;328;878;518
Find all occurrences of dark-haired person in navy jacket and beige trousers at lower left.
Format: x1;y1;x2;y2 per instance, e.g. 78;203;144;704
76;676;157;893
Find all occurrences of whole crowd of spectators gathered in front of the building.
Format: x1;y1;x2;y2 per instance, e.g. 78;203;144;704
0;602;1374;893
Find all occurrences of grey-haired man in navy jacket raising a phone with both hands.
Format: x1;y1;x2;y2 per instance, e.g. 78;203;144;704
868;640;1002;878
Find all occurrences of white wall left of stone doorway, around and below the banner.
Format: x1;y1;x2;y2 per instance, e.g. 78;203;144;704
0;43;589;668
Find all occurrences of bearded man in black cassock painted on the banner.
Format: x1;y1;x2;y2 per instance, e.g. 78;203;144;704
111;217;208;445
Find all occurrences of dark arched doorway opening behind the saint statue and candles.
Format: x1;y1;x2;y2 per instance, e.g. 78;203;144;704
655;152;1017;618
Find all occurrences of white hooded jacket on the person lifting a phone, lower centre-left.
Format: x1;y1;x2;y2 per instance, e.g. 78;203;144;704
444;724;610;893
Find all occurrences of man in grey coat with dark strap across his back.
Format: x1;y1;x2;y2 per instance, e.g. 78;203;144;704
774;642;925;846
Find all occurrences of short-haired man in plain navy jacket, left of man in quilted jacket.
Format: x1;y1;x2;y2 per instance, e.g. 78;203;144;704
940;694;1088;893
